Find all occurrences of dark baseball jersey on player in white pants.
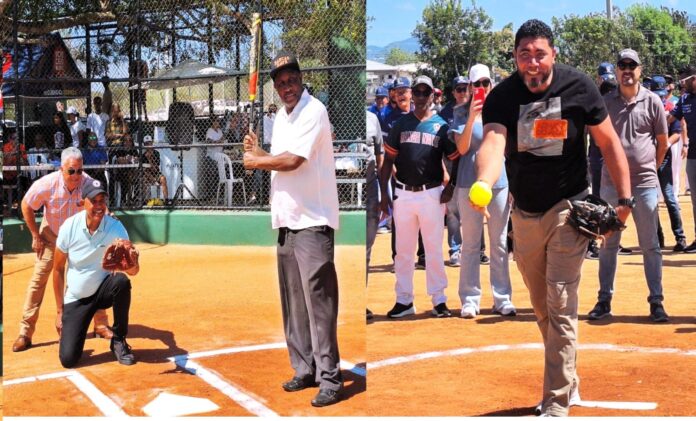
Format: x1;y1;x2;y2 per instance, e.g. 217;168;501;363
384;112;459;186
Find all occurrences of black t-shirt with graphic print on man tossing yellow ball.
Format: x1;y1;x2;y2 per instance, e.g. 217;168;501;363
483;64;608;212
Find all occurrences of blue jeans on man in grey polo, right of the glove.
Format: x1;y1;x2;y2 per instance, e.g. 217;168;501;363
598;183;664;304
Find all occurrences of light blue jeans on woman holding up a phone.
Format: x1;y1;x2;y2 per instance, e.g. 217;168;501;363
456;187;512;310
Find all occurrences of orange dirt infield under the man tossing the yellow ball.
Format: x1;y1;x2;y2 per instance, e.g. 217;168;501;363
367;196;696;416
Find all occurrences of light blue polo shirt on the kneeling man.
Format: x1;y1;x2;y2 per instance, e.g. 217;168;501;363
56;210;128;304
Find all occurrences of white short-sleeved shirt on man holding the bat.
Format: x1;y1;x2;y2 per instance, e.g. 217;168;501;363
271;90;338;229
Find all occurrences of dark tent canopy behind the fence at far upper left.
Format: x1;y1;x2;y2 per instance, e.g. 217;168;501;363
2;33;89;100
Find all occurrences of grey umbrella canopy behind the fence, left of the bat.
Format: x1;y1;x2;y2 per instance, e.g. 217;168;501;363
135;60;245;89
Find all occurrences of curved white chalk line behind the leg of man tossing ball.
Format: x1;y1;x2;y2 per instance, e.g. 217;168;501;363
367;343;696;371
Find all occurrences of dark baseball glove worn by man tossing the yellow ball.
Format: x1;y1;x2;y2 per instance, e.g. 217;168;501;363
566;194;626;240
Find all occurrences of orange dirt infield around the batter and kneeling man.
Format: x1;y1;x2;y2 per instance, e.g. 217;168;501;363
3;244;366;416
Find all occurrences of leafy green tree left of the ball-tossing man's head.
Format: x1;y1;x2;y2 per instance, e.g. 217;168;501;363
413;0;497;92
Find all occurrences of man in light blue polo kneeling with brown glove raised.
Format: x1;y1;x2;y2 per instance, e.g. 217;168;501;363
53;180;140;368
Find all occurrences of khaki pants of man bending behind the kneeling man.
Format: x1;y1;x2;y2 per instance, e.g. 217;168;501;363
19;218;109;339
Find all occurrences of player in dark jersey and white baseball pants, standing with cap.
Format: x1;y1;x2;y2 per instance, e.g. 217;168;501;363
380;76;458;318
